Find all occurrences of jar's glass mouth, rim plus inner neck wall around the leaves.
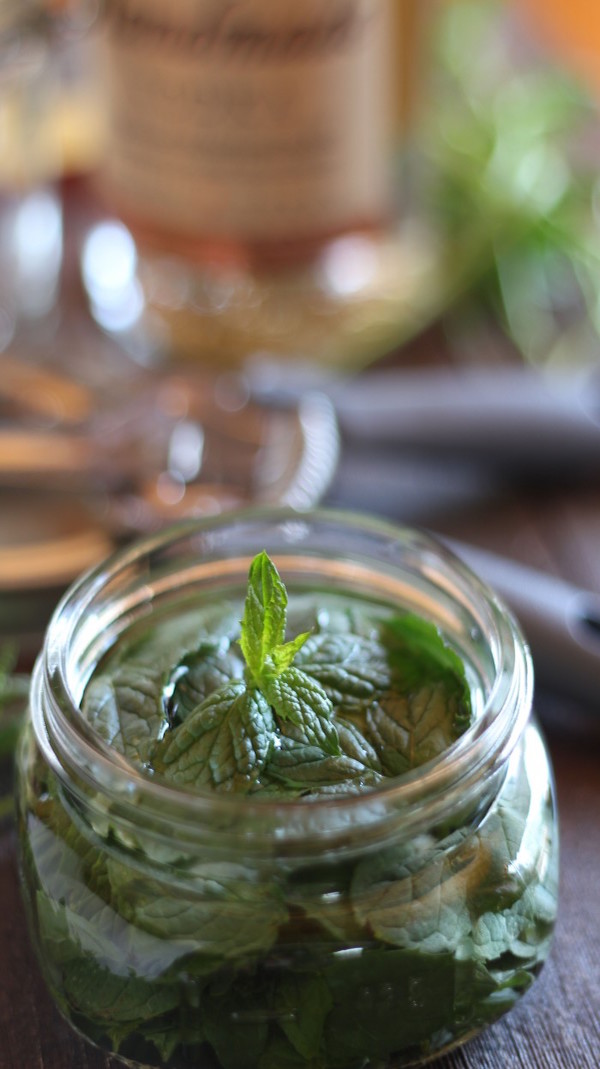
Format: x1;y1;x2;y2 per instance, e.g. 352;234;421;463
31;508;533;850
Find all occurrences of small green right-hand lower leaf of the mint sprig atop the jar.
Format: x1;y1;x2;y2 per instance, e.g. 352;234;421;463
263;667;341;754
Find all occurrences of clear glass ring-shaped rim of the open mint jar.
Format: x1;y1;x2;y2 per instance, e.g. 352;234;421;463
31;507;533;840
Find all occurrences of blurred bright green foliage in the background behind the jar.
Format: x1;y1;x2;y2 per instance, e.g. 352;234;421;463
420;0;600;366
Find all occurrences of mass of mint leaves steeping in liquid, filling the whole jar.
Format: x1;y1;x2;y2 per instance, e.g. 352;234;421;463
19;521;557;1069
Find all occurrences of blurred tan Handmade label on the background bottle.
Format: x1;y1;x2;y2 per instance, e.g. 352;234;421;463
105;0;394;242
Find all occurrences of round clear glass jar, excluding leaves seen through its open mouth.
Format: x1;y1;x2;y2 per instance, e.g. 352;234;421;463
18;510;557;1069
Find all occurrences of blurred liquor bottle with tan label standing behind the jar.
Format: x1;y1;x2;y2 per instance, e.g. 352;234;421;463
91;0;433;369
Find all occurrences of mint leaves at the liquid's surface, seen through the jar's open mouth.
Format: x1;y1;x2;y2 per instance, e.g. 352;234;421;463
83;551;472;796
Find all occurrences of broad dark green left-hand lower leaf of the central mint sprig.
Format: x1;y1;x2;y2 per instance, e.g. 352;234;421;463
152;682;275;791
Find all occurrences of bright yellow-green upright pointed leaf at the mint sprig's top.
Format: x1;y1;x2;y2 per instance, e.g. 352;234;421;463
240;549;288;683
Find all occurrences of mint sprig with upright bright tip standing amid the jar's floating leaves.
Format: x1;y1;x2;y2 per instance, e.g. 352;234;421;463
152;551;341;791
